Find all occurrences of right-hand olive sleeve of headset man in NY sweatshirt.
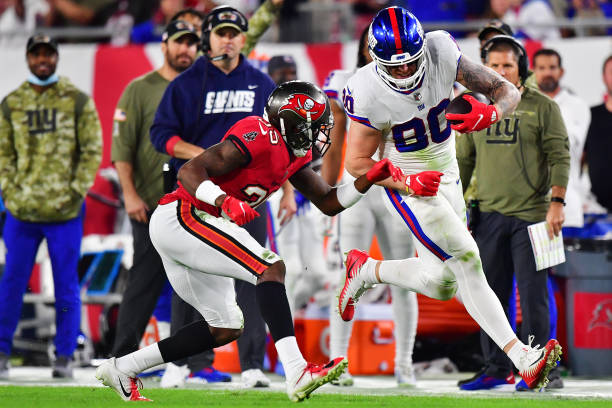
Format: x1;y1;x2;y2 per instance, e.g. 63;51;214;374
540;101;570;187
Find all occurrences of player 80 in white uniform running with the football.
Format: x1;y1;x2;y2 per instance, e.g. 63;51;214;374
339;7;561;388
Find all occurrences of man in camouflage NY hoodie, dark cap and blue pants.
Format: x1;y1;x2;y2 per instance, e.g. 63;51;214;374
0;34;102;379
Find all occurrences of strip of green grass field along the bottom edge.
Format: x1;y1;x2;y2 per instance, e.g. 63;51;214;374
0;386;612;408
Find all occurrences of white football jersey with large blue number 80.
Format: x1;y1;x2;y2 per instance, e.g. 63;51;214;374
341;31;461;177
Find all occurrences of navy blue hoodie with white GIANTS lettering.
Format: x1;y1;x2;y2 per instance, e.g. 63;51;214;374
151;55;275;171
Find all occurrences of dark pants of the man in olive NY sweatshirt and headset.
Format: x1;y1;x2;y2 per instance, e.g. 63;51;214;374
473;212;550;377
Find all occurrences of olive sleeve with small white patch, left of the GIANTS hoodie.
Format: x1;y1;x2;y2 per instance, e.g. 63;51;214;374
111;83;142;163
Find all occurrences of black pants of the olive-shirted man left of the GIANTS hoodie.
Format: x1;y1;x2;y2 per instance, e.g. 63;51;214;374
111;215;215;372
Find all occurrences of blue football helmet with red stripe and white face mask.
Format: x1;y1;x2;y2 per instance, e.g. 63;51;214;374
368;7;427;92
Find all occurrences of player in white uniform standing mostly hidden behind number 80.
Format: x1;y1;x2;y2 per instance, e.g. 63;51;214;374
321;28;418;386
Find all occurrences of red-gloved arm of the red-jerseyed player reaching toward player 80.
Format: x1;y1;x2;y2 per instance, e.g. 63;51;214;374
289;159;405;216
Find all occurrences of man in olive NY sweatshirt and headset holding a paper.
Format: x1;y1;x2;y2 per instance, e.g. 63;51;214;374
457;35;569;390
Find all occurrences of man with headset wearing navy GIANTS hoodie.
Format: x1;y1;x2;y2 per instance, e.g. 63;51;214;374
151;6;274;386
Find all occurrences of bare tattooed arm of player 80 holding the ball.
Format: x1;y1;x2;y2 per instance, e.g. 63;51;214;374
457;55;521;116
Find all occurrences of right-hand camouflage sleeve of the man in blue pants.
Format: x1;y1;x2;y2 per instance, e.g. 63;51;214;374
71;98;102;197
